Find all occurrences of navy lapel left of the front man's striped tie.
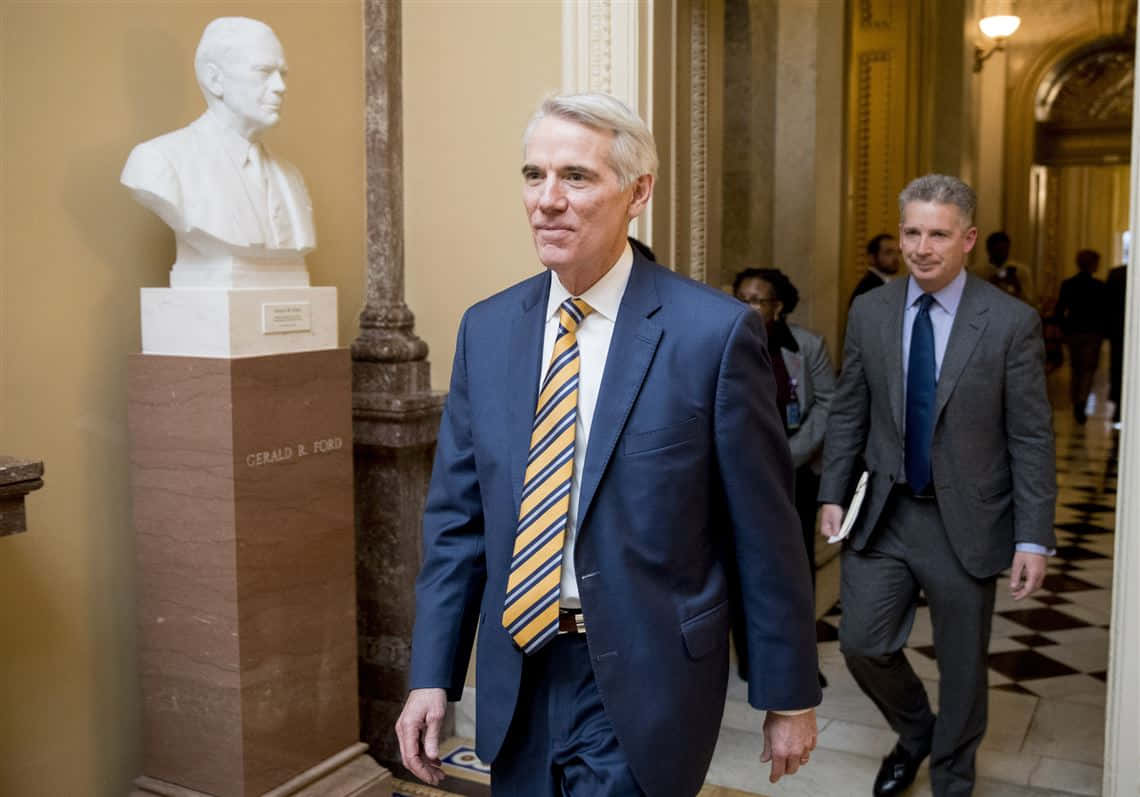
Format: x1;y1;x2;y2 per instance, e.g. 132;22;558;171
507;273;551;518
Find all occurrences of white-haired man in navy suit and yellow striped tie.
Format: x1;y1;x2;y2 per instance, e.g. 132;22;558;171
397;95;821;797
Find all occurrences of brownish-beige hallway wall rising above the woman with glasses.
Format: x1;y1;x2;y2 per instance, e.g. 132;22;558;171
709;0;846;353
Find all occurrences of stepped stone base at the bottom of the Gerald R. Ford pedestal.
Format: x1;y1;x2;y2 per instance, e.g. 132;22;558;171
129;743;392;797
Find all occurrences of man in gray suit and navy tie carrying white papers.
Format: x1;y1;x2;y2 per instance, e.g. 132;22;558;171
820;174;1056;797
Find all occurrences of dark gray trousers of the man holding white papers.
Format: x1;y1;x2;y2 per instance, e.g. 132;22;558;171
839;491;996;797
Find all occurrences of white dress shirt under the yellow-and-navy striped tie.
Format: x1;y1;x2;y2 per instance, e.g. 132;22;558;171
538;244;634;609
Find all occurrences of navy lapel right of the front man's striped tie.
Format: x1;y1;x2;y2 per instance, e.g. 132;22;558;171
578;262;661;535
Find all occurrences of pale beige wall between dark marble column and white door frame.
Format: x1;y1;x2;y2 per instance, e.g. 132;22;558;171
404;0;562;389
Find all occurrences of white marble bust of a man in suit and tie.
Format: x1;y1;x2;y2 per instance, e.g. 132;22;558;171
121;17;316;287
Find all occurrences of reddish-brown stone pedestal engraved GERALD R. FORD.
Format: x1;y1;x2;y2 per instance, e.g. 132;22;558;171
129;349;390;797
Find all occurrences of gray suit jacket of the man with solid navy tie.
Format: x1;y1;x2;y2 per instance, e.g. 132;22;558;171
820;276;1057;578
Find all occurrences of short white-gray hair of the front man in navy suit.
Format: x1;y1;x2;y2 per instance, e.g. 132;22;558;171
522;93;658;188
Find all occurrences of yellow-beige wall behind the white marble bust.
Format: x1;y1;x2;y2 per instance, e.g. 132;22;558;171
0;0;364;797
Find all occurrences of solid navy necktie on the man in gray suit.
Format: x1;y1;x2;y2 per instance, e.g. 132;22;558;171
906;293;937;493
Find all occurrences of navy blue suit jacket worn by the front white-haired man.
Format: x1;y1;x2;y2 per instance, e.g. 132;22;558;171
410;255;820;796
